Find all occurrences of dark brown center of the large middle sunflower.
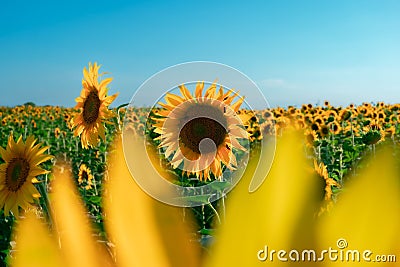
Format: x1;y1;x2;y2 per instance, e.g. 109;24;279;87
179;117;227;154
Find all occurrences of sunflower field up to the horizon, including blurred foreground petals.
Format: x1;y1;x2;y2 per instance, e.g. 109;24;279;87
0;64;400;266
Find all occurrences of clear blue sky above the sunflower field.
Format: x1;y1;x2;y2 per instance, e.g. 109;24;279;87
0;0;400;106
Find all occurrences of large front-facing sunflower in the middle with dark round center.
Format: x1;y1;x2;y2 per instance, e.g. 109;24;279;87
153;82;248;180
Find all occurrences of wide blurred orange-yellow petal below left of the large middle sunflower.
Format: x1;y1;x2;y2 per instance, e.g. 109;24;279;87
104;138;200;267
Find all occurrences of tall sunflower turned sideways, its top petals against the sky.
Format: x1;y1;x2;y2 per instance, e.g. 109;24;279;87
73;63;118;151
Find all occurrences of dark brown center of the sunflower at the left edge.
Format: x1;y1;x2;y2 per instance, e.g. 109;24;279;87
6;158;30;192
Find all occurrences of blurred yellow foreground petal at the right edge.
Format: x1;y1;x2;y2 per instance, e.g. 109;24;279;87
317;149;400;266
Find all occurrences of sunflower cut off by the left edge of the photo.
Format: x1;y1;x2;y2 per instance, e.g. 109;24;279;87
0;135;53;216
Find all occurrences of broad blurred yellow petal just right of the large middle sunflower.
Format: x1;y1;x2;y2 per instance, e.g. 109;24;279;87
206;133;323;267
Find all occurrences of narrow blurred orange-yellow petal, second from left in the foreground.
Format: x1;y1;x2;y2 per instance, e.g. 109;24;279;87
50;163;111;267
